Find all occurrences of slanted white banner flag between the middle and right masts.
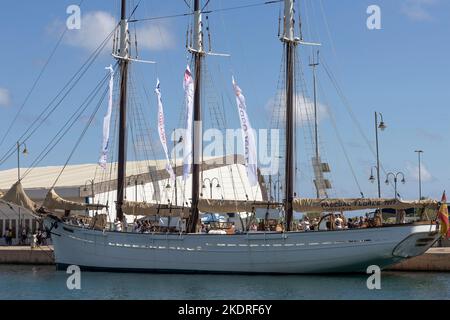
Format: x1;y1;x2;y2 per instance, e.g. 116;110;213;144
232;77;258;186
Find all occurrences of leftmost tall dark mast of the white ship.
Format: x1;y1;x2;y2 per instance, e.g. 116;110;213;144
116;0;130;221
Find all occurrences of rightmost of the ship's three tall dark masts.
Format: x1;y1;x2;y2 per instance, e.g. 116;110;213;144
282;0;297;231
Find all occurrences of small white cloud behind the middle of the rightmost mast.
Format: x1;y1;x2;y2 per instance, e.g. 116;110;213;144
267;93;329;125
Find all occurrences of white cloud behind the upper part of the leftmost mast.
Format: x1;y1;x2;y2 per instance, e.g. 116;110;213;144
58;11;175;52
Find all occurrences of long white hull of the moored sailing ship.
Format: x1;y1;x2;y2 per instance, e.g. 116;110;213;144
46;218;438;274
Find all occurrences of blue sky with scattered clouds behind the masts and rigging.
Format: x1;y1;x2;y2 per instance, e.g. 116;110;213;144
0;0;450;198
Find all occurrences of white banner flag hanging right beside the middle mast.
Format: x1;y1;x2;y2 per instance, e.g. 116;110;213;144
183;66;194;180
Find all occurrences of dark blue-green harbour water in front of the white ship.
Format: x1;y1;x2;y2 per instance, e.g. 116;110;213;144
0;265;450;300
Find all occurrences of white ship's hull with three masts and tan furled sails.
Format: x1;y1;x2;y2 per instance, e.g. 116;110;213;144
0;0;439;274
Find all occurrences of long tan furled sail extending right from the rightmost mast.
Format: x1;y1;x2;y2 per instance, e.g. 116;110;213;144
293;199;438;212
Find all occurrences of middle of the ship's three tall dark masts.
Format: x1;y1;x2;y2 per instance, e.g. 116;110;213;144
187;0;204;233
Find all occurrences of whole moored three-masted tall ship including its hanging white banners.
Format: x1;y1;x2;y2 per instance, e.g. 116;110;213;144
0;0;439;274
